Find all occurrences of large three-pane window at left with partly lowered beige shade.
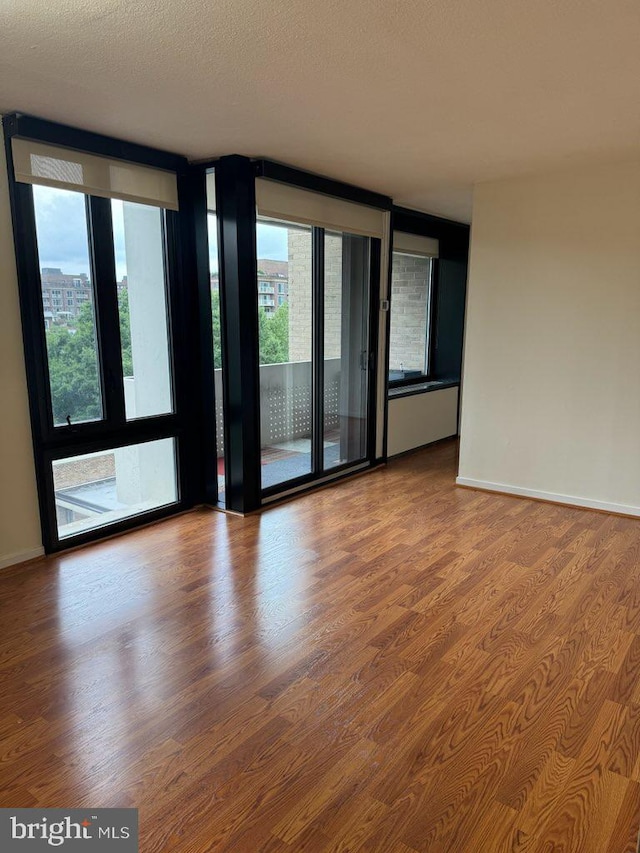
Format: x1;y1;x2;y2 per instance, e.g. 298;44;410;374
12;129;188;550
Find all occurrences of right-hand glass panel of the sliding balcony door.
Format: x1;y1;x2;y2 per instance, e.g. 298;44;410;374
323;232;369;469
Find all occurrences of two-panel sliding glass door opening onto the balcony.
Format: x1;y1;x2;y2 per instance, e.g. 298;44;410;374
256;218;372;496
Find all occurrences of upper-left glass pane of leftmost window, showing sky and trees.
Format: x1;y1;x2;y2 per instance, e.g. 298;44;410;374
33;186;103;426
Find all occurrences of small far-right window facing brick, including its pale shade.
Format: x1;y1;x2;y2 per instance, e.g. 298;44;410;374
389;235;437;385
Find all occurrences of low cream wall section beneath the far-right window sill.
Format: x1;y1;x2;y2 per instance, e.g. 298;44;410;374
387;387;458;456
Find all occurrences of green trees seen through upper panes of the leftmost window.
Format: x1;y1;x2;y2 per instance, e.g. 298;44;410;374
46;293;133;424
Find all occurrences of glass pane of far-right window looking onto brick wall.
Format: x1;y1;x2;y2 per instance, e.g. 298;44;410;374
389;252;431;381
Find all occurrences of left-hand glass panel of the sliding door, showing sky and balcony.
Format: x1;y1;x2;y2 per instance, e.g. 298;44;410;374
257;216;312;489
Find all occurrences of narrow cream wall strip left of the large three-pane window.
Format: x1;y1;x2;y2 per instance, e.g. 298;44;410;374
0;125;42;567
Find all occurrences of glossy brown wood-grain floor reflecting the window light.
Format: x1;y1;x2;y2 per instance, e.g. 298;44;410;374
0;443;640;853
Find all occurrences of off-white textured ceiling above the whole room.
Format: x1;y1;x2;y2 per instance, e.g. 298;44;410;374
0;0;640;220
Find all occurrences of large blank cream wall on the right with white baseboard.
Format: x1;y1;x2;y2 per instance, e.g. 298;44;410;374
458;161;640;514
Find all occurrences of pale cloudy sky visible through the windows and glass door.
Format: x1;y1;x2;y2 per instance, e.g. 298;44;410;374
33;186;288;280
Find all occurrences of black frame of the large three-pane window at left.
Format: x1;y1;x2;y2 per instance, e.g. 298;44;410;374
3;114;196;553
